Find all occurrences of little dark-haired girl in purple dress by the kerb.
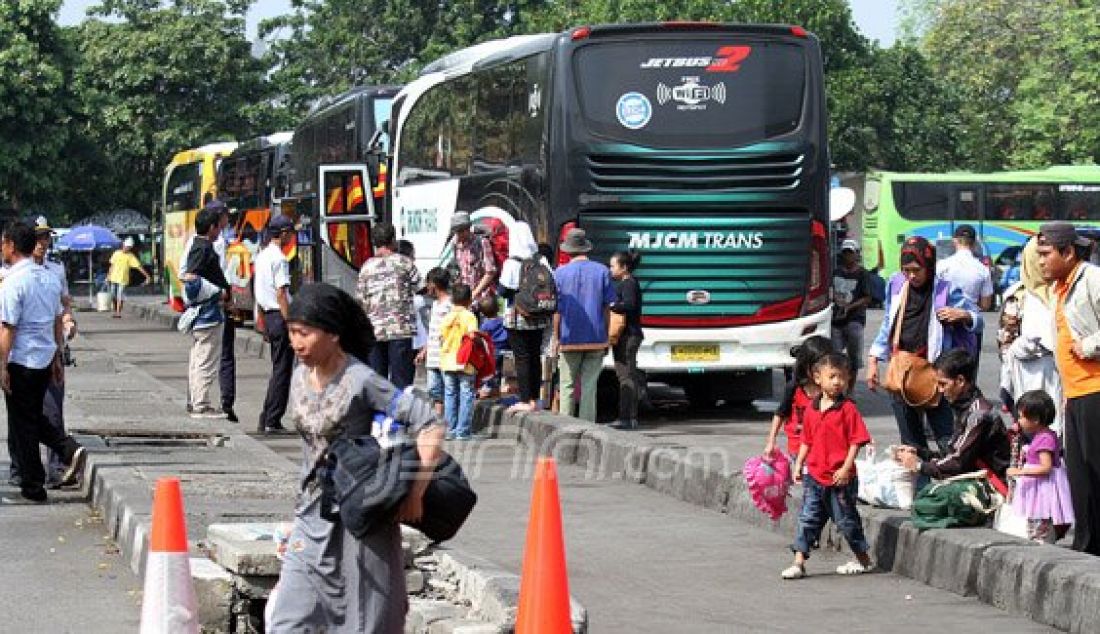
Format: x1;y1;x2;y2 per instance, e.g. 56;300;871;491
1008;390;1074;544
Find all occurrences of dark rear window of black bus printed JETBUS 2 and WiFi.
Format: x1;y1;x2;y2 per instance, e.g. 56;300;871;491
573;37;806;147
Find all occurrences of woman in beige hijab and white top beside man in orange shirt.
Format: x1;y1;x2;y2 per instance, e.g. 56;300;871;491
998;238;1062;433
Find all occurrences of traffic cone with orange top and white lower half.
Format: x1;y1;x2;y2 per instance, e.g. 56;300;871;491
141;478;199;634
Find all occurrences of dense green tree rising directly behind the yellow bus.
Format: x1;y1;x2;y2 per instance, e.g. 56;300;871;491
72;0;286;210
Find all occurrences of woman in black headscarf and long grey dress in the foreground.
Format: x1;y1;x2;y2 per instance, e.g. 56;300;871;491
267;284;444;634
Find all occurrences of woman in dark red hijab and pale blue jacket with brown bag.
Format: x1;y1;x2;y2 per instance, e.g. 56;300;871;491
867;237;981;451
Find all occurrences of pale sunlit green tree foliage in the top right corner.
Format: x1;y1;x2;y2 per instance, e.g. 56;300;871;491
921;0;1100;170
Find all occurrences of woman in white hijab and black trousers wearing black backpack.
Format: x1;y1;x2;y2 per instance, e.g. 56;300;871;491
501;222;550;412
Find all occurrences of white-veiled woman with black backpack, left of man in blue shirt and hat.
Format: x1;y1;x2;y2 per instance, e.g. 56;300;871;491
501;222;554;412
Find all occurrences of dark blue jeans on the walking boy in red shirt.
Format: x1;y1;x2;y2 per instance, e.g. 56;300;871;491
791;473;871;558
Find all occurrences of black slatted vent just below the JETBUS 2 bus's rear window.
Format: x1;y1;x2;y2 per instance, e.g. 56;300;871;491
585;152;805;193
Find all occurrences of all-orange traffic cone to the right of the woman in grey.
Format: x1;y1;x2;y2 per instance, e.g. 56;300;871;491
516;458;573;634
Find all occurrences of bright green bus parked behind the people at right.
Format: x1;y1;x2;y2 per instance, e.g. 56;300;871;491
862;165;1100;277
